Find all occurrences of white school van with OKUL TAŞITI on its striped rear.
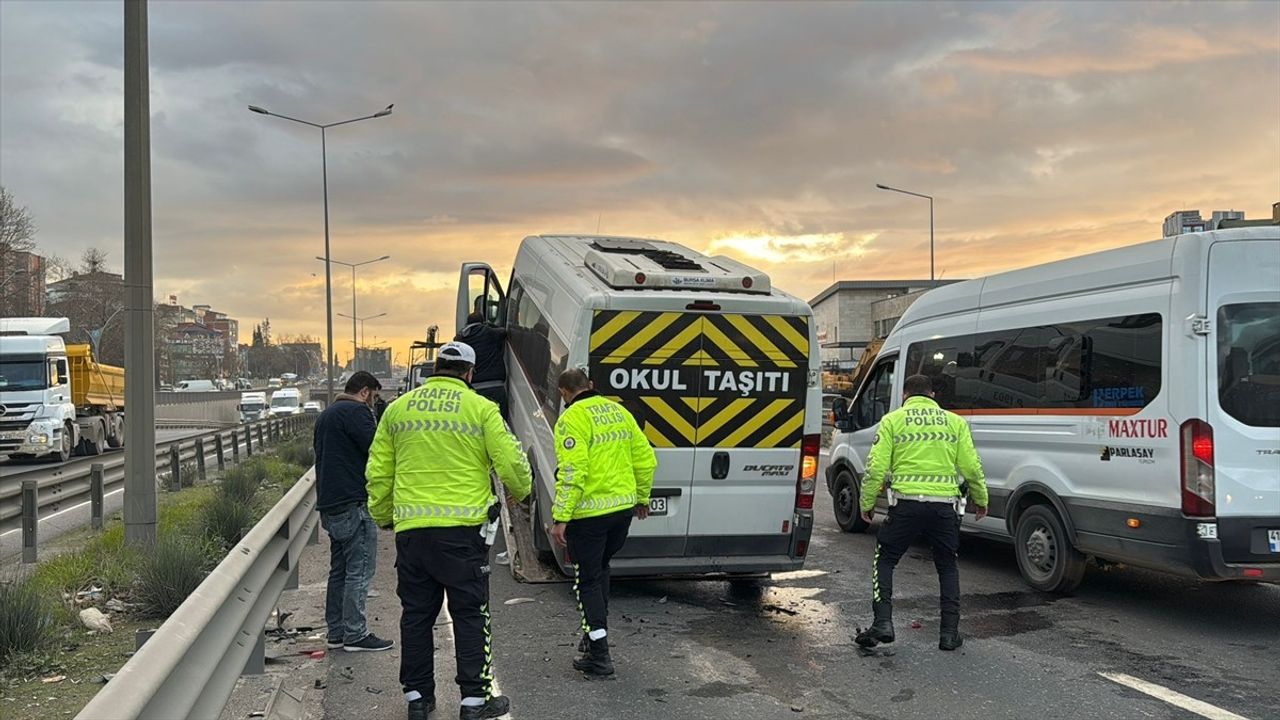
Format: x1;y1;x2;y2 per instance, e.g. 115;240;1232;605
457;236;822;575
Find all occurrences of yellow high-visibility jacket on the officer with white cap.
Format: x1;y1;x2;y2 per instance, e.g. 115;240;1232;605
365;375;532;532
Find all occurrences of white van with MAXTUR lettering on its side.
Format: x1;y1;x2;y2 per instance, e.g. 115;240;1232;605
827;227;1280;592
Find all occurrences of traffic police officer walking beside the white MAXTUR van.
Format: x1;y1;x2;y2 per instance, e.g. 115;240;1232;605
855;375;987;650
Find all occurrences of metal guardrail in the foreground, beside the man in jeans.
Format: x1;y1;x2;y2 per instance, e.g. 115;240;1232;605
76;461;319;720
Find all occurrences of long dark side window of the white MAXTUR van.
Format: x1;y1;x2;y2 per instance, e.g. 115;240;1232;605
904;313;1162;410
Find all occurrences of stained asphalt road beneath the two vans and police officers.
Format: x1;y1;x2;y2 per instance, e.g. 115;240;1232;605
254;458;1280;720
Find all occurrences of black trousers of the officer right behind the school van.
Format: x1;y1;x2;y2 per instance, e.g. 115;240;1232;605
564;507;634;633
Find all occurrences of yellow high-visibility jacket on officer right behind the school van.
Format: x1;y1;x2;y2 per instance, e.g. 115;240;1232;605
552;391;658;523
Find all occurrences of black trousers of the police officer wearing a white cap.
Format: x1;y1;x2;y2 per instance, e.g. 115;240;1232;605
396;525;493;698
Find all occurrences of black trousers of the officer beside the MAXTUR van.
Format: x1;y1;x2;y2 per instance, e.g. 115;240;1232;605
872;500;960;628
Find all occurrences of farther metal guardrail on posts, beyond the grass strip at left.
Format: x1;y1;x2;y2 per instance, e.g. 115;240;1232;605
0;415;315;562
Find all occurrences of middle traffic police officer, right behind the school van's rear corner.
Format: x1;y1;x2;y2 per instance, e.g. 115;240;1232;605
552;369;658;676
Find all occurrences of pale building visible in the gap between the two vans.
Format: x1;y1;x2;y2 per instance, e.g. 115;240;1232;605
809;281;960;370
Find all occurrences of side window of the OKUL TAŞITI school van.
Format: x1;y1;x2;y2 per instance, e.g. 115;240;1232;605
507;275;568;424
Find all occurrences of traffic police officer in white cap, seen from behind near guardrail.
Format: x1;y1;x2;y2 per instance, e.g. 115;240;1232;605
366;342;531;720
